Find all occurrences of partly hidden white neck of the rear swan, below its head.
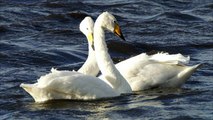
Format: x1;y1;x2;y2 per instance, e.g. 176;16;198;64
78;42;99;76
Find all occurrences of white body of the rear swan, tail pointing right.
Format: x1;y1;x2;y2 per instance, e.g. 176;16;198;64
80;14;201;91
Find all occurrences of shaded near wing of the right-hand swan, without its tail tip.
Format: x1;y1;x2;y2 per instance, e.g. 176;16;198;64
127;63;185;91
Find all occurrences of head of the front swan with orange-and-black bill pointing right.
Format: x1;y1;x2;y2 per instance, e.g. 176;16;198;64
96;12;125;40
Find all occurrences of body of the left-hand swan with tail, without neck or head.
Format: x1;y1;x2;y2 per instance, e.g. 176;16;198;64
21;68;119;102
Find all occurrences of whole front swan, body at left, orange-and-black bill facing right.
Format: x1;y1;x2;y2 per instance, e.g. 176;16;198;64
20;13;131;102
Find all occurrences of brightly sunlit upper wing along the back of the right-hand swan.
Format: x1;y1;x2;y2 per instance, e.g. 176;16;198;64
116;53;190;74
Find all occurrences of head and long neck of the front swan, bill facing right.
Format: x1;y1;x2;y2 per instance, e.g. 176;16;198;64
94;12;132;93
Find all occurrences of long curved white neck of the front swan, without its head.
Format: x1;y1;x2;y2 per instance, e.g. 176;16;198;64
94;21;132;93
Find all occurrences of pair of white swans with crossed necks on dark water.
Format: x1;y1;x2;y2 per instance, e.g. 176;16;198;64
20;12;199;102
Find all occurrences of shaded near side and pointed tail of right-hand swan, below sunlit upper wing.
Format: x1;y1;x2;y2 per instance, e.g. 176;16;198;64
123;63;201;91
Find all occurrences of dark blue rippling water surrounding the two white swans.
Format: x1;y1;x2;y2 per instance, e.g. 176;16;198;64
0;0;213;120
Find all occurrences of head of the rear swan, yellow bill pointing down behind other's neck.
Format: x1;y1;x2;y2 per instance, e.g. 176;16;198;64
79;17;95;50
